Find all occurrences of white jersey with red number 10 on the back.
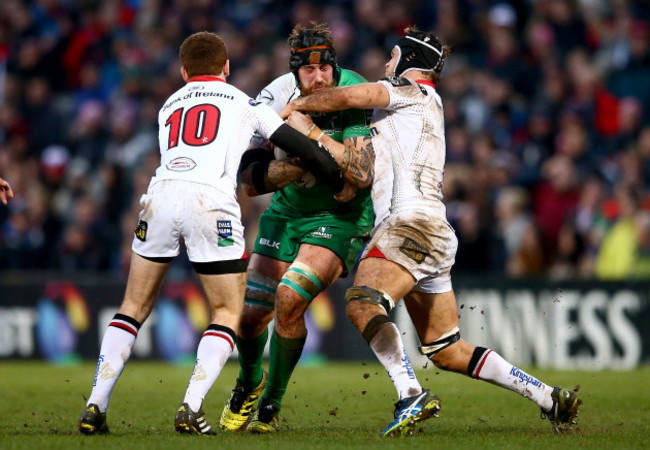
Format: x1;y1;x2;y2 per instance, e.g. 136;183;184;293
151;76;284;198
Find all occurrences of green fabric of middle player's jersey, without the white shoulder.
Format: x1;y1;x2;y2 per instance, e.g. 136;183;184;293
270;69;373;218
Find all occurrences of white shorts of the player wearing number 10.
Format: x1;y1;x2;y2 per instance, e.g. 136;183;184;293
132;180;246;263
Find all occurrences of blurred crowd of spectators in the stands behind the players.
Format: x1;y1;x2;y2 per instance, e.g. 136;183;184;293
0;0;650;279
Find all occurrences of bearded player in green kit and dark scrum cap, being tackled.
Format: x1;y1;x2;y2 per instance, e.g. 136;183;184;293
219;22;374;433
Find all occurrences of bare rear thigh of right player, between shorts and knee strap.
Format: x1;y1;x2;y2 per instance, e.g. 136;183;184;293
404;291;458;342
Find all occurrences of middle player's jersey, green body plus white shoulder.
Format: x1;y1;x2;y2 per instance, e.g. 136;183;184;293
257;68;372;216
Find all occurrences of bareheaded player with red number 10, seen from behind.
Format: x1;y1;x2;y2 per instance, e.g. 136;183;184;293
79;32;350;435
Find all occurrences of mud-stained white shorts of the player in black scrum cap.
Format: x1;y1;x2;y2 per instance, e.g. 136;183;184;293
361;211;458;294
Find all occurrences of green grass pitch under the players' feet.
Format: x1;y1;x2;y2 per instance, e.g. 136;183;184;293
0;361;650;450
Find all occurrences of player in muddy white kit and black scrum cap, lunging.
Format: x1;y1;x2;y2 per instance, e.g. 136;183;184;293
281;28;582;436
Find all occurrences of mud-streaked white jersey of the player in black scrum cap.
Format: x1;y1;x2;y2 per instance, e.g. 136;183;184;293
370;77;445;226
